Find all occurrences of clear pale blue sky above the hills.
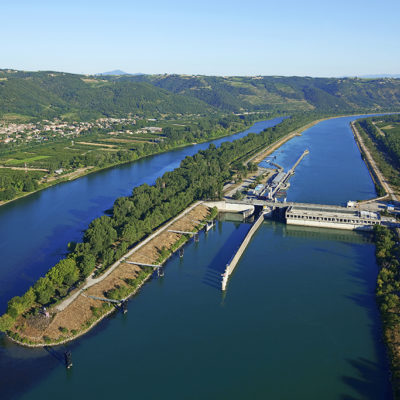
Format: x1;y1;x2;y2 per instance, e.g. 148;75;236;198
0;0;400;76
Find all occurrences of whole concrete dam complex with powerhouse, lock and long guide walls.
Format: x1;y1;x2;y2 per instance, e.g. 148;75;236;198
207;150;400;291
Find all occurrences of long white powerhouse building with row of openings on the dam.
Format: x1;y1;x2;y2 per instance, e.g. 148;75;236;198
285;204;381;230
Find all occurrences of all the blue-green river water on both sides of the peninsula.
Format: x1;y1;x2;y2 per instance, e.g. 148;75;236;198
0;117;391;400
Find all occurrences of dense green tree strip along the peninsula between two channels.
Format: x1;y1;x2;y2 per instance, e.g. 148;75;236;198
0;115;315;331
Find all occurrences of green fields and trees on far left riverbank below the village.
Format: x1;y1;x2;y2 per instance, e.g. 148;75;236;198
0;114;266;201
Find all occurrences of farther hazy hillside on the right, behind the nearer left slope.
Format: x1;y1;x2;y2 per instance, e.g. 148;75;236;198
119;75;400;112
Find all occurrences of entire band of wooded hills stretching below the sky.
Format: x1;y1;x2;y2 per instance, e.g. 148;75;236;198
0;70;400;120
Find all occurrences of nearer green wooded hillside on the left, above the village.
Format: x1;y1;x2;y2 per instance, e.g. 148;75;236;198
0;70;212;120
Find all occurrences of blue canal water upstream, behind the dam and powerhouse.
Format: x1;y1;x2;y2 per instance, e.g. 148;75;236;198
264;117;375;205
